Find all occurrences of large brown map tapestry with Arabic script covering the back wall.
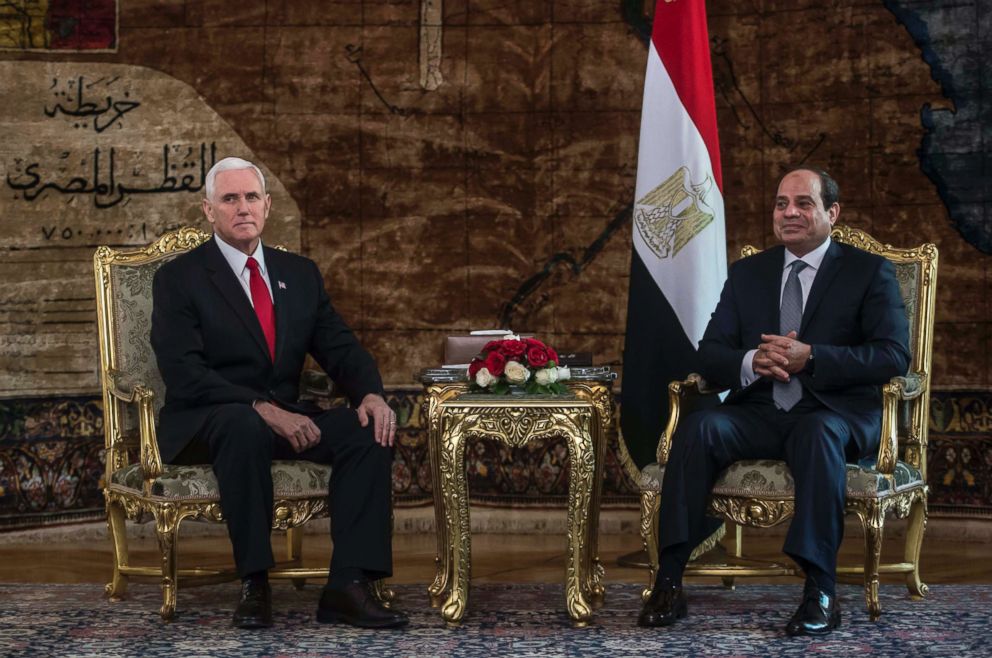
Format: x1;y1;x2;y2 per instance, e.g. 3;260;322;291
0;0;992;518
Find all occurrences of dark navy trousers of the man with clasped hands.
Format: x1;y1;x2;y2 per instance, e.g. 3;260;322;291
658;395;857;575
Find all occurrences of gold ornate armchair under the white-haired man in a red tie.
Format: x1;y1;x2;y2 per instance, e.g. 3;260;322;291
93;228;340;620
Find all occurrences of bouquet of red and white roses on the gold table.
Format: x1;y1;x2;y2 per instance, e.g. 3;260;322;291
468;335;571;395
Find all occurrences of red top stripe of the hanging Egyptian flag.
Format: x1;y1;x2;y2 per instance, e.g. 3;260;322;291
651;0;723;194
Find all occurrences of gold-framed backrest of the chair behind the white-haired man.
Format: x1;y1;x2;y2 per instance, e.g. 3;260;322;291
93;228;210;468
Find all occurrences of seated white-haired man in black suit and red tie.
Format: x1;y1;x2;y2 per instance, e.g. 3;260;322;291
151;158;407;628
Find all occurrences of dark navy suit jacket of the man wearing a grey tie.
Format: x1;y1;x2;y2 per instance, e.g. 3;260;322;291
699;242;910;456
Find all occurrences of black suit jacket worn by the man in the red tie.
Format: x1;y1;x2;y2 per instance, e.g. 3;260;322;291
151;238;382;462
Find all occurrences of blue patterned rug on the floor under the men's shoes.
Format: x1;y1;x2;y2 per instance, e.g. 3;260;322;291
0;583;992;658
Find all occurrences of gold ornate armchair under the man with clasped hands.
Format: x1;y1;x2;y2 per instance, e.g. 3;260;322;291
640;226;937;620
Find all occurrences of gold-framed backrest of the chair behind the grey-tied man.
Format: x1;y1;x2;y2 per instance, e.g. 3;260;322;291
741;225;937;478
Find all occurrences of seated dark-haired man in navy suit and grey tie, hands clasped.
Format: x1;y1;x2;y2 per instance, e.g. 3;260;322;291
638;167;910;635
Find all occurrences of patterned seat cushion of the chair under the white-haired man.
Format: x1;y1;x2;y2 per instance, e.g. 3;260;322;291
111;460;331;500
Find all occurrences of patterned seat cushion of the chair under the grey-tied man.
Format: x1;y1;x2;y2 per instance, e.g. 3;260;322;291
640;459;923;500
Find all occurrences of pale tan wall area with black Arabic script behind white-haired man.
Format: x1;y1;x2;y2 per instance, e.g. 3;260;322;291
0;62;300;396
